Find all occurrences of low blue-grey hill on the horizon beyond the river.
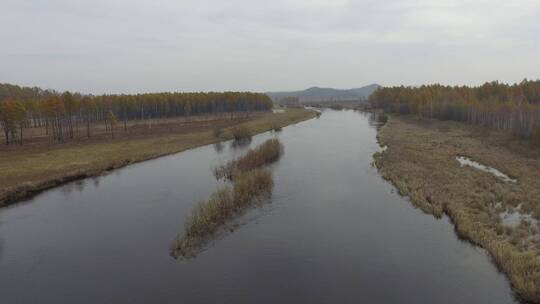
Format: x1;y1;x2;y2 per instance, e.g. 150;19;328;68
266;84;380;103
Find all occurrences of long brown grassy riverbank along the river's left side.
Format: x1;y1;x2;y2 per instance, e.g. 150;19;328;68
0;109;317;207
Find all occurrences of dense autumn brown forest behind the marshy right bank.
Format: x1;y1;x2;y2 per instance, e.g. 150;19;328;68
369;79;540;141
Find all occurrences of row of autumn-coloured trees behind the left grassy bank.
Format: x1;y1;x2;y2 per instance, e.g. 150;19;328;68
0;84;272;145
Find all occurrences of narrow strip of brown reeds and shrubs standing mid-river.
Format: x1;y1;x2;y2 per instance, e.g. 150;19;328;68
171;138;283;258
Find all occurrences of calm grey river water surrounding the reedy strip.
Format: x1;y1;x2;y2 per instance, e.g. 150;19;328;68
0;110;516;304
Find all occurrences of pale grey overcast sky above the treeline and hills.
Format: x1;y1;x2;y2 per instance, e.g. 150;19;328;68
0;0;540;93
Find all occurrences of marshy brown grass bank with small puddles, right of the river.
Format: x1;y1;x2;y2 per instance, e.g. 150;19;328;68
375;115;540;302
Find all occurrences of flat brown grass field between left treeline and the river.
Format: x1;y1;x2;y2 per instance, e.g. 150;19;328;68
0;109;316;206
